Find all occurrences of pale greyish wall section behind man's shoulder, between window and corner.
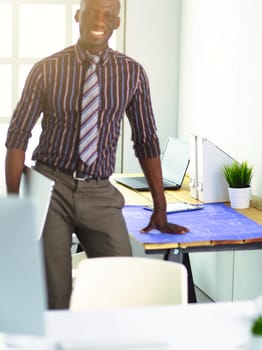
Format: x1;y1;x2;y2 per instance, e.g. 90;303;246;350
123;0;181;172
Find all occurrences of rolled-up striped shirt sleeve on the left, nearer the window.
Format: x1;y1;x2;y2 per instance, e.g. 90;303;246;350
5;64;43;151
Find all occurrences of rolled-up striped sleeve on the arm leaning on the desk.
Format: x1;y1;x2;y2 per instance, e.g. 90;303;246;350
126;66;160;159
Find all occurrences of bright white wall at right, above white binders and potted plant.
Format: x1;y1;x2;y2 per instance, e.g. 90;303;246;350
178;0;262;197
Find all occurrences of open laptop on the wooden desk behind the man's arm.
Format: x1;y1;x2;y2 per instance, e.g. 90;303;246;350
113;136;189;191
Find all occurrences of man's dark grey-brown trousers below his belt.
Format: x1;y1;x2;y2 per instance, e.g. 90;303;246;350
35;163;132;309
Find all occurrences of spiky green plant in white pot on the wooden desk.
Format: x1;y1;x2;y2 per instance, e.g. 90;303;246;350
223;161;253;209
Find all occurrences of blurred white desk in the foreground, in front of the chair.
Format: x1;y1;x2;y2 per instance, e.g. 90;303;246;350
46;301;256;350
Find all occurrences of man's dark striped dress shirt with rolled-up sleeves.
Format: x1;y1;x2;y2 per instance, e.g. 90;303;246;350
6;42;160;177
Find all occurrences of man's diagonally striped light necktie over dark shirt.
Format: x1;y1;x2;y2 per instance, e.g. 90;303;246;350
79;55;99;165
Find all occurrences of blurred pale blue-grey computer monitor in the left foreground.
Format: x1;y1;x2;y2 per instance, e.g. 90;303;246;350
0;195;46;335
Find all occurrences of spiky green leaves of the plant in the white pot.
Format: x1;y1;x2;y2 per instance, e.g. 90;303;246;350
222;161;253;188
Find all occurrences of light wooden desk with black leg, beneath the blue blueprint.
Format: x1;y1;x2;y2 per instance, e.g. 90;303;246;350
111;175;262;302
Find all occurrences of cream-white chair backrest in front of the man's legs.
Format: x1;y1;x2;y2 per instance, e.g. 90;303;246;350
70;257;187;311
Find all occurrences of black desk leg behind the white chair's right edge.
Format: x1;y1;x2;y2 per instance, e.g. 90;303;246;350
164;249;197;303
